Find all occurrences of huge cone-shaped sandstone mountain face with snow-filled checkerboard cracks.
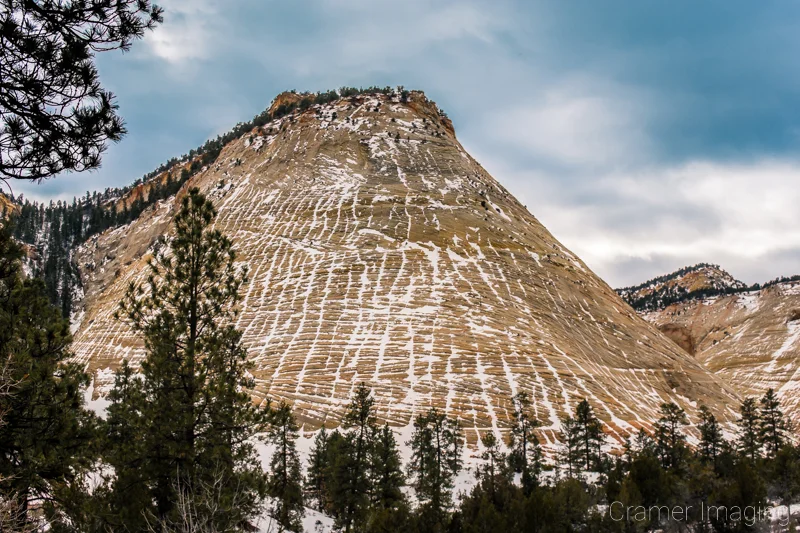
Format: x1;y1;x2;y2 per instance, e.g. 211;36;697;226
74;92;737;443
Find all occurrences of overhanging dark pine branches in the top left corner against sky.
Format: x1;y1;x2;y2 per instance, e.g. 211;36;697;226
0;0;162;181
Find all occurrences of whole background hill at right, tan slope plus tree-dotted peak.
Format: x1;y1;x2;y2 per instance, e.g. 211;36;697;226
619;265;800;423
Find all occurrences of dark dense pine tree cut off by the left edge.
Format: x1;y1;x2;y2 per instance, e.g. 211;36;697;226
0;225;97;528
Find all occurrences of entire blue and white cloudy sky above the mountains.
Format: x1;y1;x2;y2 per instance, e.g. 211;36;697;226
15;0;800;286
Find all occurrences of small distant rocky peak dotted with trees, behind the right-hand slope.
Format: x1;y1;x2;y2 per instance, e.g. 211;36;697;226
617;263;747;311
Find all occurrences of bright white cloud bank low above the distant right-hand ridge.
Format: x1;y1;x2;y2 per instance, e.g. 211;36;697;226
478;154;800;286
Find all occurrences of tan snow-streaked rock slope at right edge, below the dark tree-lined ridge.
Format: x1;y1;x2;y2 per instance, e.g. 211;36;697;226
645;281;800;424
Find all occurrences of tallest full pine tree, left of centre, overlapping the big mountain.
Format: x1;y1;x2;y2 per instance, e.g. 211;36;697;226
109;189;268;528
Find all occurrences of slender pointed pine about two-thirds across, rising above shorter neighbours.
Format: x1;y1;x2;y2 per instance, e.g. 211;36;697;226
508;392;542;495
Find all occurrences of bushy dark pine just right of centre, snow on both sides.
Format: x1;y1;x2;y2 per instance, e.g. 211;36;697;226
408;408;462;524
